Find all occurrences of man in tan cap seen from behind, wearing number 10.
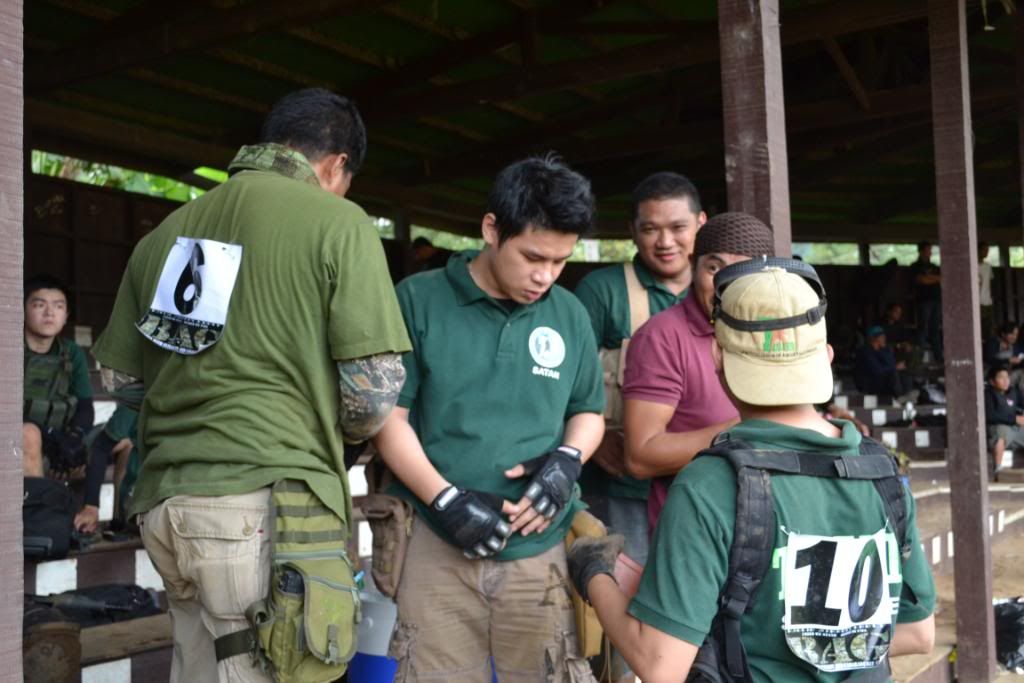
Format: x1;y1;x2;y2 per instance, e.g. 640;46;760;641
569;254;935;683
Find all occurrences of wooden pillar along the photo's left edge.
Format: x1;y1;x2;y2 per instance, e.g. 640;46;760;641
0;0;25;681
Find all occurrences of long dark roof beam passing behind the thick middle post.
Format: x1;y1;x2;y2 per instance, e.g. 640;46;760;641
367;0;927;123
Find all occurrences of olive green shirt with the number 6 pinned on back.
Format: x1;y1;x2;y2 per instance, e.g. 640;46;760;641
93;144;410;520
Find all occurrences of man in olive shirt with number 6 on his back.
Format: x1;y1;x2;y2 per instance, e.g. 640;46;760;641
94;89;410;683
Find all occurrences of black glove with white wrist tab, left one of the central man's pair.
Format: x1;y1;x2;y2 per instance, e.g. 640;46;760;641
430;486;512;559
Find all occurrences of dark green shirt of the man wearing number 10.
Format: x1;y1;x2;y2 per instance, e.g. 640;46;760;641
629;420;935;683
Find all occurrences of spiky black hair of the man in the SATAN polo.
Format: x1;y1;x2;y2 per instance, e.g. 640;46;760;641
487;154;596;245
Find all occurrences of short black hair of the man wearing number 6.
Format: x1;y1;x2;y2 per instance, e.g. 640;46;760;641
260;88;367;175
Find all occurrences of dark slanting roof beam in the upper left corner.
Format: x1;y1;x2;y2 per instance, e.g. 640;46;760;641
26;0;377;93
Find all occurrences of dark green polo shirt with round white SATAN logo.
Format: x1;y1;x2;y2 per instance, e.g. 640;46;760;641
393;252;604;560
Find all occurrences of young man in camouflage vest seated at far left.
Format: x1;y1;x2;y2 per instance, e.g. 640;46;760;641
22;274;105;532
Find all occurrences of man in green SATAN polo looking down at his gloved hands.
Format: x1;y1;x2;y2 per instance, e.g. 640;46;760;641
375;158;604;683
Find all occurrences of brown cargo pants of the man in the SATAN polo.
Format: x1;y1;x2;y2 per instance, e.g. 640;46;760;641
391;518;594;683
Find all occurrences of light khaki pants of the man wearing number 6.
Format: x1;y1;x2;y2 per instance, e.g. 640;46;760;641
141;488;272;683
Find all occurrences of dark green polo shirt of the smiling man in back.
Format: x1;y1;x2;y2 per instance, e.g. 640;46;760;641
575;255;689;499
